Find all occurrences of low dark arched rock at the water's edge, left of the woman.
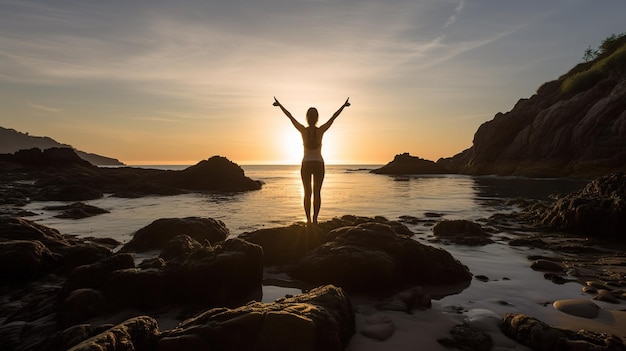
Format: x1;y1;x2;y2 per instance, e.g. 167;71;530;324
120;217;229;252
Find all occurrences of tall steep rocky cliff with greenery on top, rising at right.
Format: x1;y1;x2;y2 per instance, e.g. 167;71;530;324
437;35;626;177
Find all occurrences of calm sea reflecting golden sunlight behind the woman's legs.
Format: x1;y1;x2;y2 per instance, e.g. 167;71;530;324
26;165;584;242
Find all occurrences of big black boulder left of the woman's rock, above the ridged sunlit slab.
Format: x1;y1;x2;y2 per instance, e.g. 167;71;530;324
101;238;263;309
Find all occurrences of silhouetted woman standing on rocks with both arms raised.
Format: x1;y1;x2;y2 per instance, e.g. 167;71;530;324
274;98;350;224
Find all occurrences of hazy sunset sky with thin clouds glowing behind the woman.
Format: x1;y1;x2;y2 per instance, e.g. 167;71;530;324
0;0;626;165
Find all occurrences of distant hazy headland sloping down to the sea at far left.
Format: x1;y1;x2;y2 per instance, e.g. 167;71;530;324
0;127;124;166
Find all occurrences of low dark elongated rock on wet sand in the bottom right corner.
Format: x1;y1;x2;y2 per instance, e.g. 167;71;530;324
501;313;626;351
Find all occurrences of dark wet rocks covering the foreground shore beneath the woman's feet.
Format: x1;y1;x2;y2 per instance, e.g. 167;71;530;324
0;208;626;350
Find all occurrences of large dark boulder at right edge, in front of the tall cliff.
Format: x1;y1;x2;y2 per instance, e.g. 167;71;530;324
540;173;626;240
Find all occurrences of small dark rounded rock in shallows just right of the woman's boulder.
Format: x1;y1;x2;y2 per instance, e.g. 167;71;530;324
433;219;493;245
